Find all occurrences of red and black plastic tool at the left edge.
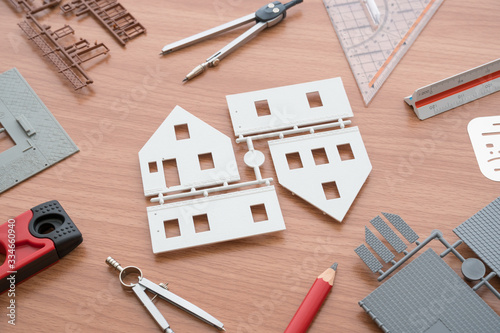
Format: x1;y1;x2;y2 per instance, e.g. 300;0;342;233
0;200;83;293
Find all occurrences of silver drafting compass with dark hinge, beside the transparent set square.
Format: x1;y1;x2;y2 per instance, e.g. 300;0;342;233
160;0;303;82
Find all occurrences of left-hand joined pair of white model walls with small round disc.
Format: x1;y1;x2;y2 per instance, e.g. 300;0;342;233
139;106;285;253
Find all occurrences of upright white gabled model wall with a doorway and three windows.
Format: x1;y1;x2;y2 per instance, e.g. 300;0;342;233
139;106;240;196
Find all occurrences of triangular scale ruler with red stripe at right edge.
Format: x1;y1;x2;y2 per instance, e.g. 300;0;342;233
405;59;500;120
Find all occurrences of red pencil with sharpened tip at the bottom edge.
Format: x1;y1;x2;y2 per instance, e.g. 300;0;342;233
284;263;337;333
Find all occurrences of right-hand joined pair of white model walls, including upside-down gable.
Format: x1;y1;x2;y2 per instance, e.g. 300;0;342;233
226;78;372;222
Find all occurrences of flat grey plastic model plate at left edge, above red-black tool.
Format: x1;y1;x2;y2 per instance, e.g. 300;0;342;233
0;68;78;193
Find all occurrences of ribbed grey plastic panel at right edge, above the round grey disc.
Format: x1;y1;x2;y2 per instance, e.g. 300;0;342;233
453;197;500;274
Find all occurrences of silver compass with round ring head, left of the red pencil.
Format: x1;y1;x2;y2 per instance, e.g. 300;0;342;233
106;257;225;333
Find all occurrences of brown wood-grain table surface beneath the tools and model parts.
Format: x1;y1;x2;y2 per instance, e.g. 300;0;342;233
0;0;500;333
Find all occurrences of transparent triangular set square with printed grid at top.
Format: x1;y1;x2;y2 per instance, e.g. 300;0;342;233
323;0;444;105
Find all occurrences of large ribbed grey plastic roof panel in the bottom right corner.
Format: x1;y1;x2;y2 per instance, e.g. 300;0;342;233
359;249;500;333
